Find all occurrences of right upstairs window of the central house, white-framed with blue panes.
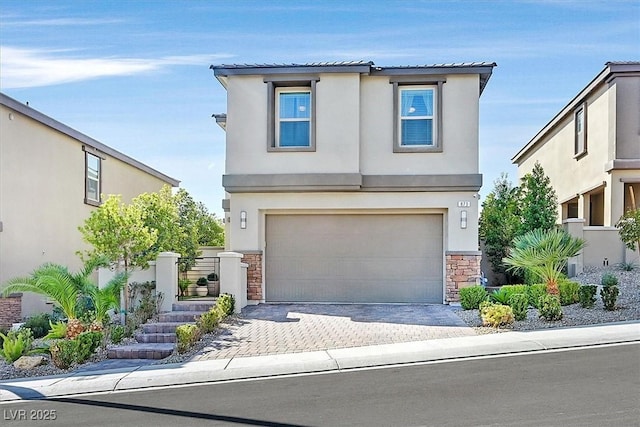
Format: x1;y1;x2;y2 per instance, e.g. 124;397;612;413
399;87;435;147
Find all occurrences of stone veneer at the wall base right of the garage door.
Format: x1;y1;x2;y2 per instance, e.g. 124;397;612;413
445;251;482;303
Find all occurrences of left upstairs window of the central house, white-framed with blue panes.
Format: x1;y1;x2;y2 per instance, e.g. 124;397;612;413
276;88;311;148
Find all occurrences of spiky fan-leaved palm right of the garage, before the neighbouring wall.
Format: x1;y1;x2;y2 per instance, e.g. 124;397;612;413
503;229;586;295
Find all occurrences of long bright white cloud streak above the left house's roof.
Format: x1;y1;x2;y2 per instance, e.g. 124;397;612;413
0;46;230;89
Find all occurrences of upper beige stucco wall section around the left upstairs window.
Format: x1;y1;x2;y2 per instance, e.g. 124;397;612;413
226;74;360;174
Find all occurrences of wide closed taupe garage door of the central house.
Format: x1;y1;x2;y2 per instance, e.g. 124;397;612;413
265;214;443;303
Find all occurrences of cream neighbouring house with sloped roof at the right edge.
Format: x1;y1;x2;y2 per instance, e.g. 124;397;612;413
512;62;640;273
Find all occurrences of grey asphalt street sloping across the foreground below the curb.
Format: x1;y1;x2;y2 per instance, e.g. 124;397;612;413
0;343;640;427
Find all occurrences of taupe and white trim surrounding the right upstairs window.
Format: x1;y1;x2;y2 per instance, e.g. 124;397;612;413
389;76;447;153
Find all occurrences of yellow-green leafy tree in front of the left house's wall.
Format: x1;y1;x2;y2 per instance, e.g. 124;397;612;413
78;195;158;273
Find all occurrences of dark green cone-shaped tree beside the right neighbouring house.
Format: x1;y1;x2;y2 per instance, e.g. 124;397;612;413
518;162;558;235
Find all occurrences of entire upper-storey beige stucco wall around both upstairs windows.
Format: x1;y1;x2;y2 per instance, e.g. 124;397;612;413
226;73;479;175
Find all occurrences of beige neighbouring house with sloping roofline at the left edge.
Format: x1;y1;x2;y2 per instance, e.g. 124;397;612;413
0;94;179;316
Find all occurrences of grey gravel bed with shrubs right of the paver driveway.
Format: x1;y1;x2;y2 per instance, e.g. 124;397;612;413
456;267;640;335
